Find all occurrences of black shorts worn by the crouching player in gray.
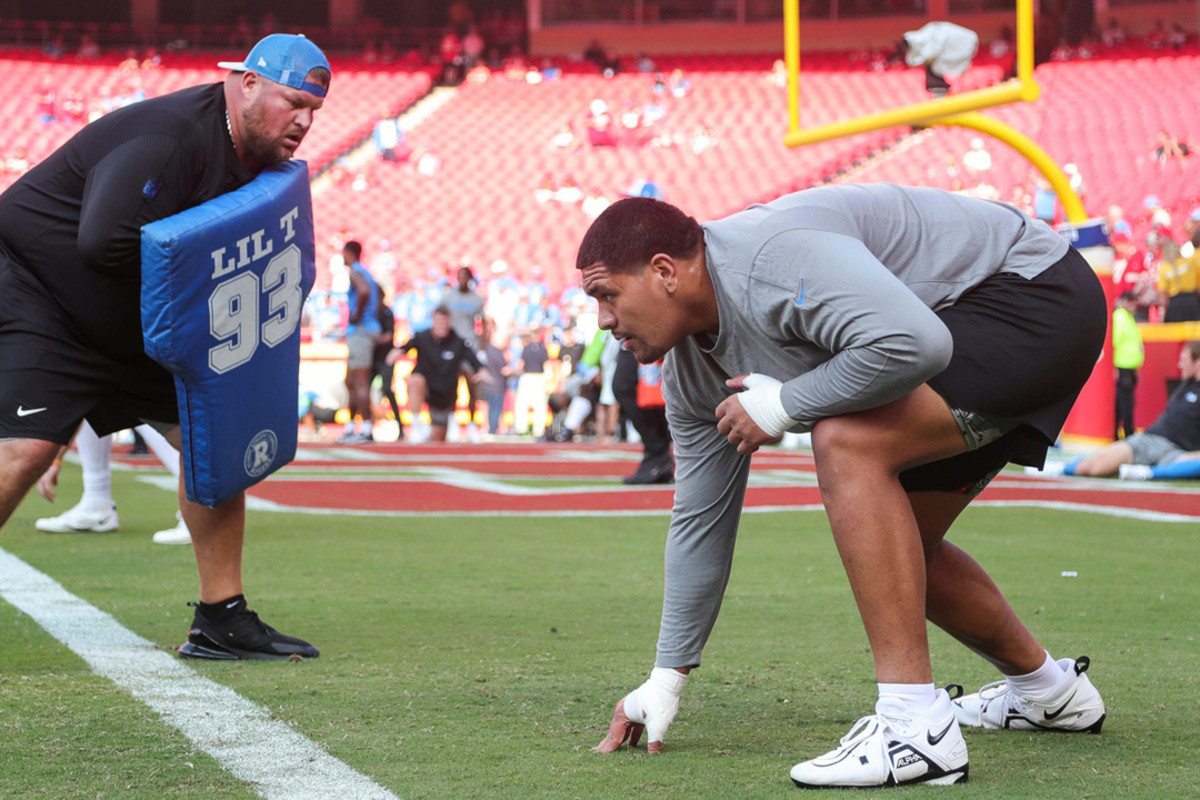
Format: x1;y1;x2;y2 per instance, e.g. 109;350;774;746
900;248;1109;493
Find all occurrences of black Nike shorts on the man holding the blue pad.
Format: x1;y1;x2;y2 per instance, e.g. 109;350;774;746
0;259;179;445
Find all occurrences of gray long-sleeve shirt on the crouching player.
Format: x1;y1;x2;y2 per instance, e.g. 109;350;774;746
656;184;1068;667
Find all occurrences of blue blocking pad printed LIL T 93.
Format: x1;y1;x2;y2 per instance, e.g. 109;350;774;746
142;161;316;507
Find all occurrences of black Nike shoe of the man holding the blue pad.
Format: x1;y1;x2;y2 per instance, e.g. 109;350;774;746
179;601;319;661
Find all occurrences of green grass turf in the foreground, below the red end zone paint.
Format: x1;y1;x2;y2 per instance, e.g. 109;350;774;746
0;467;1200;800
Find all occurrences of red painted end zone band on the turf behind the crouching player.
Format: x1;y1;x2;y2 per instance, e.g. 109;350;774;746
226;444;1200;519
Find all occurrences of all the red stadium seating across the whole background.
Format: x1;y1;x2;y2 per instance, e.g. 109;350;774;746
0;44;1200;288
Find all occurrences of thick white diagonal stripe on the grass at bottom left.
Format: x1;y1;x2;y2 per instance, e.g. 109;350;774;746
0;548;398;800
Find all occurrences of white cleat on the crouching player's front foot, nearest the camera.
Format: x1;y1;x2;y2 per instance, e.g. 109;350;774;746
791;690;967;789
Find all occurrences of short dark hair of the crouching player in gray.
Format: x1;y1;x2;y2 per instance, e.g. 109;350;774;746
575;197;704;272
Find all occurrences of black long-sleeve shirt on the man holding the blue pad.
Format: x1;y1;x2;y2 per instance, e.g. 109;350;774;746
0;83;254;360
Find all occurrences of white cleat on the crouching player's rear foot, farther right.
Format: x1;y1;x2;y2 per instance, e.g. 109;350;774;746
954;656;1106;733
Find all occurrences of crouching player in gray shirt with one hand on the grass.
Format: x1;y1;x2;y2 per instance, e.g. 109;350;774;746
576;185;1108;787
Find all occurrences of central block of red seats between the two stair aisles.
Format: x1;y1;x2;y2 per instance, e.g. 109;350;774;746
314;64;964;291
